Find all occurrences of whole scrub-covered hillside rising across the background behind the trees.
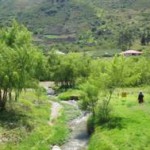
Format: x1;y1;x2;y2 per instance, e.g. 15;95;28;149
0;0;150;52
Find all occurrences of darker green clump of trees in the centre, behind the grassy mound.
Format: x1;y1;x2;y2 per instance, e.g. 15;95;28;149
48;52;90;88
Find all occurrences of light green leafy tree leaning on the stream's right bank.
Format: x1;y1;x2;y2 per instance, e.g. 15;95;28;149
81;56;127;122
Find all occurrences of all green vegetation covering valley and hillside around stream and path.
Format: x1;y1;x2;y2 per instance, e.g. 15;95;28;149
0;0;150;150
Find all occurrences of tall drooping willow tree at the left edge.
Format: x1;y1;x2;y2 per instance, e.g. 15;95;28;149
0;21;39;110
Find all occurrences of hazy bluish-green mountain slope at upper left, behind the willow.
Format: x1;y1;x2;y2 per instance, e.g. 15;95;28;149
0;0;95;34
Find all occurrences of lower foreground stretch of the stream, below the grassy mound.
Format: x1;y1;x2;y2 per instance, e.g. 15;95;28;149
52;101;89;150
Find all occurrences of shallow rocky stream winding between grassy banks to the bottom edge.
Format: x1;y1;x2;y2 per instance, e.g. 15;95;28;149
40;82;89;150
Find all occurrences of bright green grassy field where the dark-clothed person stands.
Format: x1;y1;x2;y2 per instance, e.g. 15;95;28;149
88;88;150;150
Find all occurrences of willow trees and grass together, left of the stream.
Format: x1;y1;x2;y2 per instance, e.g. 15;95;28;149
0;22;69;150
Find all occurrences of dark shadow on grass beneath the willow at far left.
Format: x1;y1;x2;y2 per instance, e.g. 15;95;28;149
0;110;27;129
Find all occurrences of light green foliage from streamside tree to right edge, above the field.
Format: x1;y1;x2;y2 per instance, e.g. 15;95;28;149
80;56;150;131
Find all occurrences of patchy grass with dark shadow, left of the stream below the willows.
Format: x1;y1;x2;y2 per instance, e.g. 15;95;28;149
0;91;69;150
